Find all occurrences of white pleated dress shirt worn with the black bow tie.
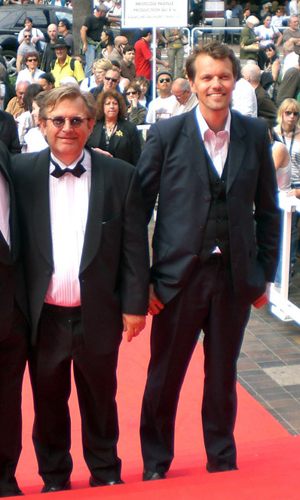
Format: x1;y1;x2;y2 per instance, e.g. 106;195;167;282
45;146;91;307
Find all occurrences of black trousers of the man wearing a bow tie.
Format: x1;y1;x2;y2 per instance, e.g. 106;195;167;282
29;304;121;485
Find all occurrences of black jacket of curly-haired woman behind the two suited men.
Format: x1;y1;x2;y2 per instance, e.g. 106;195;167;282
87;120;141;166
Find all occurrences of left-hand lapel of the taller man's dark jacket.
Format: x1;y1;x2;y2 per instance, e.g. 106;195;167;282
182;108;210;192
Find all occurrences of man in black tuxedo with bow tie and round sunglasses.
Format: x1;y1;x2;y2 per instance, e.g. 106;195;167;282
13;86;149;492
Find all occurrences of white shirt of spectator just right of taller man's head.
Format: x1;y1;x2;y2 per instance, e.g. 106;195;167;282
231;78;257;118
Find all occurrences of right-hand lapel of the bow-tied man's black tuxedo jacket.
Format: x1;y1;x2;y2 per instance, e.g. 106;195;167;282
80;150;105;273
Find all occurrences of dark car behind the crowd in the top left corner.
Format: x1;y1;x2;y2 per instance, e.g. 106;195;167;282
0;4;73;76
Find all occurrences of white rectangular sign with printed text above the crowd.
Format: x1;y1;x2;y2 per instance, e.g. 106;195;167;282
122;0;188;28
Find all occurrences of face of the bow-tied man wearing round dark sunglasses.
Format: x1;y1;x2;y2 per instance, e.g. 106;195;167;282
40;97;94;165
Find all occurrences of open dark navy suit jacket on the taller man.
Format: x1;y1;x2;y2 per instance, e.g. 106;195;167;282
138;110;280;307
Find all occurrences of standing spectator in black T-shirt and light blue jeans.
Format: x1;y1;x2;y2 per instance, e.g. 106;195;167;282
80;4;108;76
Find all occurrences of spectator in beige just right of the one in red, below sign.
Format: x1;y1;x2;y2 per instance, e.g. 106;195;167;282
165;28;184;79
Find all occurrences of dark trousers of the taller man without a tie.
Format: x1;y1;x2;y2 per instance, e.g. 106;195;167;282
140;257;250;472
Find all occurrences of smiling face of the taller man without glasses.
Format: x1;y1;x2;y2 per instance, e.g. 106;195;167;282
189;54;235;118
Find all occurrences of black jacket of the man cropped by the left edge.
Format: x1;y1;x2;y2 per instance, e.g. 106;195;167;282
0;141;28;341
